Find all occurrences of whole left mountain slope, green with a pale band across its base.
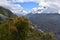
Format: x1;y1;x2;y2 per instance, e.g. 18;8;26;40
0;7;17;23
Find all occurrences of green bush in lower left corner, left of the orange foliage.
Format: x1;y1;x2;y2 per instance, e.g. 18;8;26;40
0;21;11;40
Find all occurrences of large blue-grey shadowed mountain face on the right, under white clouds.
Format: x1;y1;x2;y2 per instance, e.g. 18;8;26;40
28;13;60;40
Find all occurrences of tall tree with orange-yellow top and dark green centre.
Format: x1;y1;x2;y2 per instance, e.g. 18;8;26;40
13;16;30;40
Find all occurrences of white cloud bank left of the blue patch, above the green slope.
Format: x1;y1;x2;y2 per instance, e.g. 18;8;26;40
0;0;27;15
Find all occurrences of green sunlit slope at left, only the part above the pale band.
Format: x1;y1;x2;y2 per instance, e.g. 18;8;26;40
0;6;16;18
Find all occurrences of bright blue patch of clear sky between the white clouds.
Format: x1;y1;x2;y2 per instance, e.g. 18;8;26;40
20;2;39;11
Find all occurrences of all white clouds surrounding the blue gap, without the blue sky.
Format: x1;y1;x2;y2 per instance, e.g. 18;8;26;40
0;0;60;14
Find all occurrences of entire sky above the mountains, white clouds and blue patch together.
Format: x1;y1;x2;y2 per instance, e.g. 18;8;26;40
0;0;60;14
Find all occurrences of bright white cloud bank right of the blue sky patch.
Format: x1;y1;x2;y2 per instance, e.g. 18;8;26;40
32;0;60;13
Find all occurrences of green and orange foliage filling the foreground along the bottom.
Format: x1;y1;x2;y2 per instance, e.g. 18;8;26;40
0;17;55;40
